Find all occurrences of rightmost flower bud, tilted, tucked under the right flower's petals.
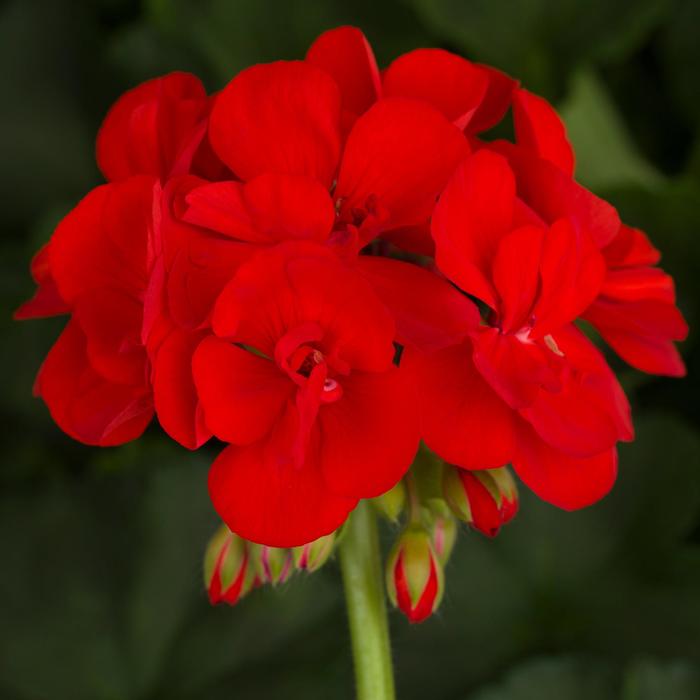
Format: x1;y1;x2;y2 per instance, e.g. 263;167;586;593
443;466;518;537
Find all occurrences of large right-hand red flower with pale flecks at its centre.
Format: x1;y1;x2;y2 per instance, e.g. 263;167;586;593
405;151;632;508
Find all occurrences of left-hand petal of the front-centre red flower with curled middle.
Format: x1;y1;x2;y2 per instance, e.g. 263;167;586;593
192;337;296;445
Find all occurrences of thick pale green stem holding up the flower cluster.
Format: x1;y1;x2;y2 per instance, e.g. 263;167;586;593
340;501;395;700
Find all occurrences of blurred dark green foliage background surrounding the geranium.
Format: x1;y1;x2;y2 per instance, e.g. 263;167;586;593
0;0;700;700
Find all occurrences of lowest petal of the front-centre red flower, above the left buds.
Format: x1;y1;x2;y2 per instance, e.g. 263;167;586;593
209;429;357;547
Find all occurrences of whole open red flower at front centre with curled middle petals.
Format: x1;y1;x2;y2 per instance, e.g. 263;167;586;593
194;243;418;547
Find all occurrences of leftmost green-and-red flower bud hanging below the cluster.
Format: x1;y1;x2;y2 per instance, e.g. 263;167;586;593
204;525;253;605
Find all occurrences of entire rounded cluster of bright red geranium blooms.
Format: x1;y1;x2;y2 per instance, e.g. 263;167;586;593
17;27;687;547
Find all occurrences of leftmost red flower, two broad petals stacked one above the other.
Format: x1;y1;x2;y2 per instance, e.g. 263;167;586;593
35;176;154;446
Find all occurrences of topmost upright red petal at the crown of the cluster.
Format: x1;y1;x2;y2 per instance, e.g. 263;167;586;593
306;27;381;115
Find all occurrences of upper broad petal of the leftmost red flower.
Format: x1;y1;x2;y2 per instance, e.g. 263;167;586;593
49;176;154;303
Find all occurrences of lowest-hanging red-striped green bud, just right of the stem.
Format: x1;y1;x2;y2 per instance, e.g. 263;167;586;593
386;526;443;622
